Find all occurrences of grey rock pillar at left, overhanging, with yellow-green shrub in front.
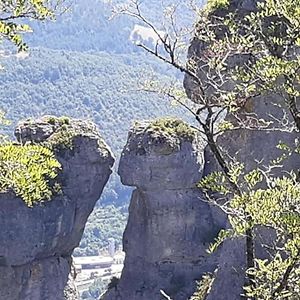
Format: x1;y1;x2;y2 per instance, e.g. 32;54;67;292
0;117;114;300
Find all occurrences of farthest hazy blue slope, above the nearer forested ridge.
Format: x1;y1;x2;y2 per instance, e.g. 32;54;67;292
27;0;202;54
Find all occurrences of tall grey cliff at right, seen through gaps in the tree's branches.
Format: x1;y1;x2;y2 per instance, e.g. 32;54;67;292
184;0;300;300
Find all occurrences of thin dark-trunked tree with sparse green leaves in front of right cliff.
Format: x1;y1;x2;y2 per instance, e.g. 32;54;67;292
113;0;300;299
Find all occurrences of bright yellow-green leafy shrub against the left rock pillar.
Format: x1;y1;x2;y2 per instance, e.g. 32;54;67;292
0;144;60;207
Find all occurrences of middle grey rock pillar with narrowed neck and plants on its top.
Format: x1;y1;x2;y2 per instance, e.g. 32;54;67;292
103;123;218;300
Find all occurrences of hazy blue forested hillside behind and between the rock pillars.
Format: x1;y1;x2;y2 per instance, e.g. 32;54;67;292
0;0;201;255
